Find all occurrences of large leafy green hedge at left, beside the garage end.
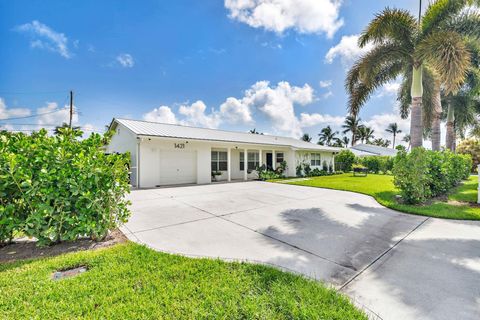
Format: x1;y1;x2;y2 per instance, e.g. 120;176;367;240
0;129;130;244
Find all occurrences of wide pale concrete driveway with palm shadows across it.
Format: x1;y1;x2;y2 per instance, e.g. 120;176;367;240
123;182;480;319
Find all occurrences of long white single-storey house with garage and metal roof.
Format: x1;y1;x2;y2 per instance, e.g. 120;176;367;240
107;119;341;188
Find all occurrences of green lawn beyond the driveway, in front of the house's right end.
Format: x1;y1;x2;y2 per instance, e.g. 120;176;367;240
283;173;480;220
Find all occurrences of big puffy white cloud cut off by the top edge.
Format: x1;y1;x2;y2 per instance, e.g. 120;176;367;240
225;0;343;38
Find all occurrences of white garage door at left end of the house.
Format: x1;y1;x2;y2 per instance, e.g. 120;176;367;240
160;150;197;185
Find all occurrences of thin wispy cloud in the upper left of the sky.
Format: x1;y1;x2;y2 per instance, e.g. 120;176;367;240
15;20;71;59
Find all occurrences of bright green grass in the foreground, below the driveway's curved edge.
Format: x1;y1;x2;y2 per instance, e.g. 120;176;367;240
0;243;367;319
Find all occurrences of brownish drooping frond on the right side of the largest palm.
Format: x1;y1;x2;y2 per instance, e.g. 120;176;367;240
415;31;470;93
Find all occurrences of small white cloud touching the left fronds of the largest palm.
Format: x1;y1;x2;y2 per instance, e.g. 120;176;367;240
325;34;373;68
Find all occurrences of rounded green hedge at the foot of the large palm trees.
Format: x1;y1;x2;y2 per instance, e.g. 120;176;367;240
393;148;472;204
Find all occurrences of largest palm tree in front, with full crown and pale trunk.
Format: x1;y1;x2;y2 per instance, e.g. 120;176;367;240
345;0;474;147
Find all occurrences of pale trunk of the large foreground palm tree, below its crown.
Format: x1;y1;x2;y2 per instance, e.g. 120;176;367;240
410;66;423;149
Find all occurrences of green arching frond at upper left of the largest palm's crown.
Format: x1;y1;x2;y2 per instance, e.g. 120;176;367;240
358;8;418;50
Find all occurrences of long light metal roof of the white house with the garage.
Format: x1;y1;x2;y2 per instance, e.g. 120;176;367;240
111;118;341;152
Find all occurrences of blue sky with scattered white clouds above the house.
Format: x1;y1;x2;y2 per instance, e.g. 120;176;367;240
0;0;428;143
